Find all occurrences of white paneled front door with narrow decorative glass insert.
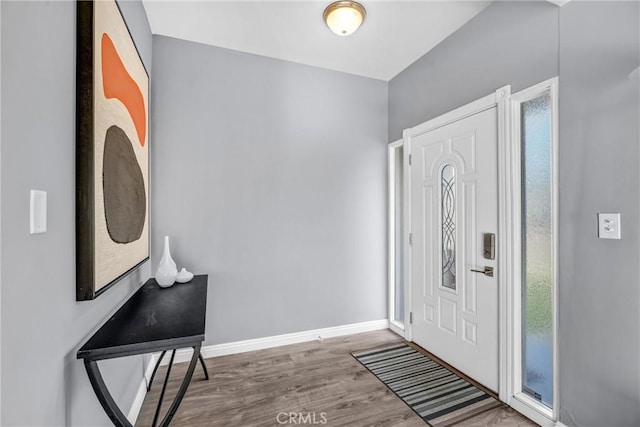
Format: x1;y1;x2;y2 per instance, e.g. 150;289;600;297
409;107;499;391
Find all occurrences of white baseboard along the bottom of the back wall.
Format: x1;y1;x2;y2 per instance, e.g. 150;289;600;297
162;319;389;365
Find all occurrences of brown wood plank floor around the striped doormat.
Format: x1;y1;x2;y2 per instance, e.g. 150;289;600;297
136;330;536;427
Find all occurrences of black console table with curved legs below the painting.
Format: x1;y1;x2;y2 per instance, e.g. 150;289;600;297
77;275;208;427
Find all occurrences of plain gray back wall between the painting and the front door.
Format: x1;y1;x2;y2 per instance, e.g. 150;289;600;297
151;36;387;344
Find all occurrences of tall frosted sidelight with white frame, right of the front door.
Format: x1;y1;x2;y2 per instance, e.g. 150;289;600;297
511;79;558;420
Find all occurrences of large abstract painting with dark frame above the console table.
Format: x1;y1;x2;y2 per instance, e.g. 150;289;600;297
76;0;149;301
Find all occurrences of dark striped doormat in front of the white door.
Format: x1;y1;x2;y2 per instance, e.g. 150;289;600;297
351;344;501;427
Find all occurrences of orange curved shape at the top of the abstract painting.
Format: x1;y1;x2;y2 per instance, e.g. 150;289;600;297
102;34;147;147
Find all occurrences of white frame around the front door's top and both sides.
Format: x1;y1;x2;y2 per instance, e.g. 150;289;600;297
402;85;519;402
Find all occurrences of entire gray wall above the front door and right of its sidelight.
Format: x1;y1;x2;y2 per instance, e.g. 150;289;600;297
389;1;640;426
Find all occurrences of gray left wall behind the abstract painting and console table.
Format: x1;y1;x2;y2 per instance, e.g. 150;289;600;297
0;1;152;426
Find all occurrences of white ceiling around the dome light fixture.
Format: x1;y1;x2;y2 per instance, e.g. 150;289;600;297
143;0;491;80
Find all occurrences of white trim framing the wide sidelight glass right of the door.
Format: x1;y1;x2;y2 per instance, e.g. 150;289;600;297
508;77;559;426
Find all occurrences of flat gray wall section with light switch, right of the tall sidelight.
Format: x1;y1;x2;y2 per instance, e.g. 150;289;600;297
559;2;640;426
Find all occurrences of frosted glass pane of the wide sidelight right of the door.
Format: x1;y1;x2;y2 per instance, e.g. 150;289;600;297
520;92;554;407
